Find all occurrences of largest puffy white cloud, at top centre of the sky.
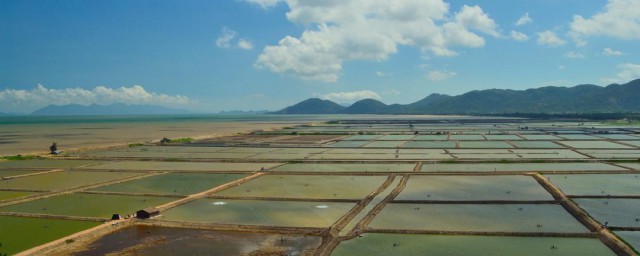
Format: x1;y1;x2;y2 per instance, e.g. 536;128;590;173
255;0;500;82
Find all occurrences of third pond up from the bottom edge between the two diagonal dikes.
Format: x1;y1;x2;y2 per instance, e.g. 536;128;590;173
395;175;553;201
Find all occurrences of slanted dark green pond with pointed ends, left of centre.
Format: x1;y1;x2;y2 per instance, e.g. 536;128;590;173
92;173;246;195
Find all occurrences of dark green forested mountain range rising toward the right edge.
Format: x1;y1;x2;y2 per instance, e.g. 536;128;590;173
273;79;640;114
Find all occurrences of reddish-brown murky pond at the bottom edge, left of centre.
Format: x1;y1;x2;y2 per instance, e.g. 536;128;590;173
65;225;322;256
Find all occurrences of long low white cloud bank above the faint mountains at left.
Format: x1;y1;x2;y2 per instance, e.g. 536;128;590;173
0;84;195;112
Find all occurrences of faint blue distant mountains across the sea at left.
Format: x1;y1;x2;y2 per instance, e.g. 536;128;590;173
31;103;190;116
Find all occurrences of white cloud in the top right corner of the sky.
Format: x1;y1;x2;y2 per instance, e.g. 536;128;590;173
569;0;640;41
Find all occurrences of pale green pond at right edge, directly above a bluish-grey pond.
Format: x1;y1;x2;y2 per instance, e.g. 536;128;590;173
545;174;640;196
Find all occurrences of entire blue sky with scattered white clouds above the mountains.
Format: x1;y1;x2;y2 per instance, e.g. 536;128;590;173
0;0;640;113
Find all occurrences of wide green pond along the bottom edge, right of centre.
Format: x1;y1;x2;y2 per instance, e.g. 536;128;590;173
331;233;616;256
